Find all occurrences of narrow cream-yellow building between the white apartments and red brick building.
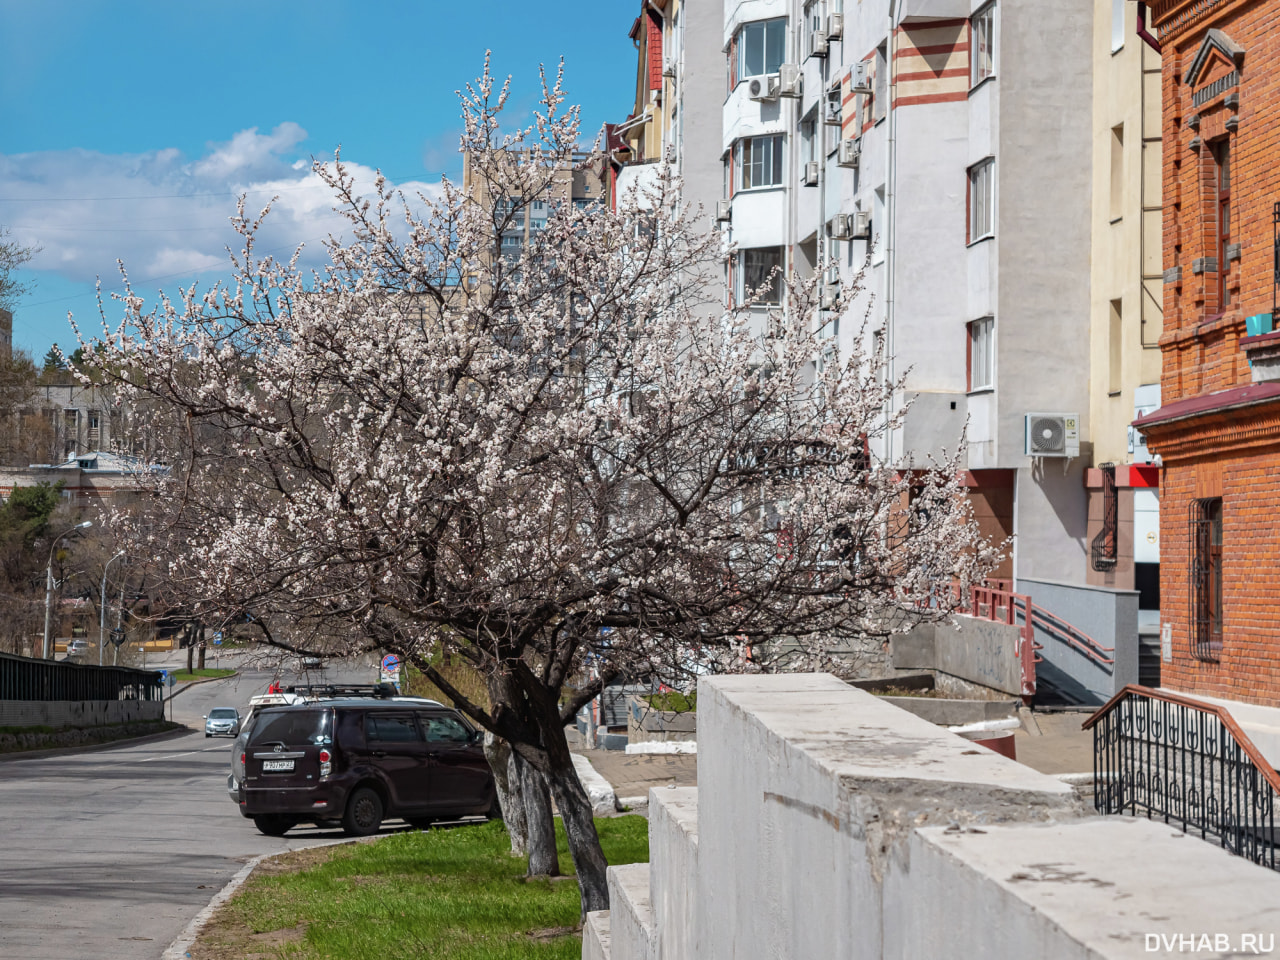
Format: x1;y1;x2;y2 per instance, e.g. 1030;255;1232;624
1085;0;1164;686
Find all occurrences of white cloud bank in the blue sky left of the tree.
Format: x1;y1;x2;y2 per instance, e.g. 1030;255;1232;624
0;128;439;289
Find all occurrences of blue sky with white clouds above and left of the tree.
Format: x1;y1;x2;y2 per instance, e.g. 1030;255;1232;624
0;0;640;360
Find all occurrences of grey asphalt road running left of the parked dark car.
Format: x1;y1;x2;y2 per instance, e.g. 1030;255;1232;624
0;647;398;960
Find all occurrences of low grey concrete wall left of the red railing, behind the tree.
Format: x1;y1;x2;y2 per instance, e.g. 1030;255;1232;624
891;614;1023;696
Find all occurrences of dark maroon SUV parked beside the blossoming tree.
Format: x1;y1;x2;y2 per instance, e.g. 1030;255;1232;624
238;699;498;837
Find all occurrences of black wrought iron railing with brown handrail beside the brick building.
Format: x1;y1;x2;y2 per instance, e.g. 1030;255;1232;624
1084;685;1280;869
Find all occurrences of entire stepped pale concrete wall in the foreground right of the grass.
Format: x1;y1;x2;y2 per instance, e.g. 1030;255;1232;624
582;675;1280;960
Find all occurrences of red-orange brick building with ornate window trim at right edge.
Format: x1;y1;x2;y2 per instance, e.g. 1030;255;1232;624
1137;0;1280;705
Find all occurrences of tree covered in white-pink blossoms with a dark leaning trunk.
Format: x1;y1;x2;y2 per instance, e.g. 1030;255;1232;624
77;65;995;911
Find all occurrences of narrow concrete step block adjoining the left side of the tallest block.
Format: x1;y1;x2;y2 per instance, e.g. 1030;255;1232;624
649;787;699;960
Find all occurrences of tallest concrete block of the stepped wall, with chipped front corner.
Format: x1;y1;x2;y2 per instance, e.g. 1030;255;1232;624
696;675;1084;960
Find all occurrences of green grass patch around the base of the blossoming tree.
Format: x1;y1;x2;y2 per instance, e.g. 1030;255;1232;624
212;817;649;960
